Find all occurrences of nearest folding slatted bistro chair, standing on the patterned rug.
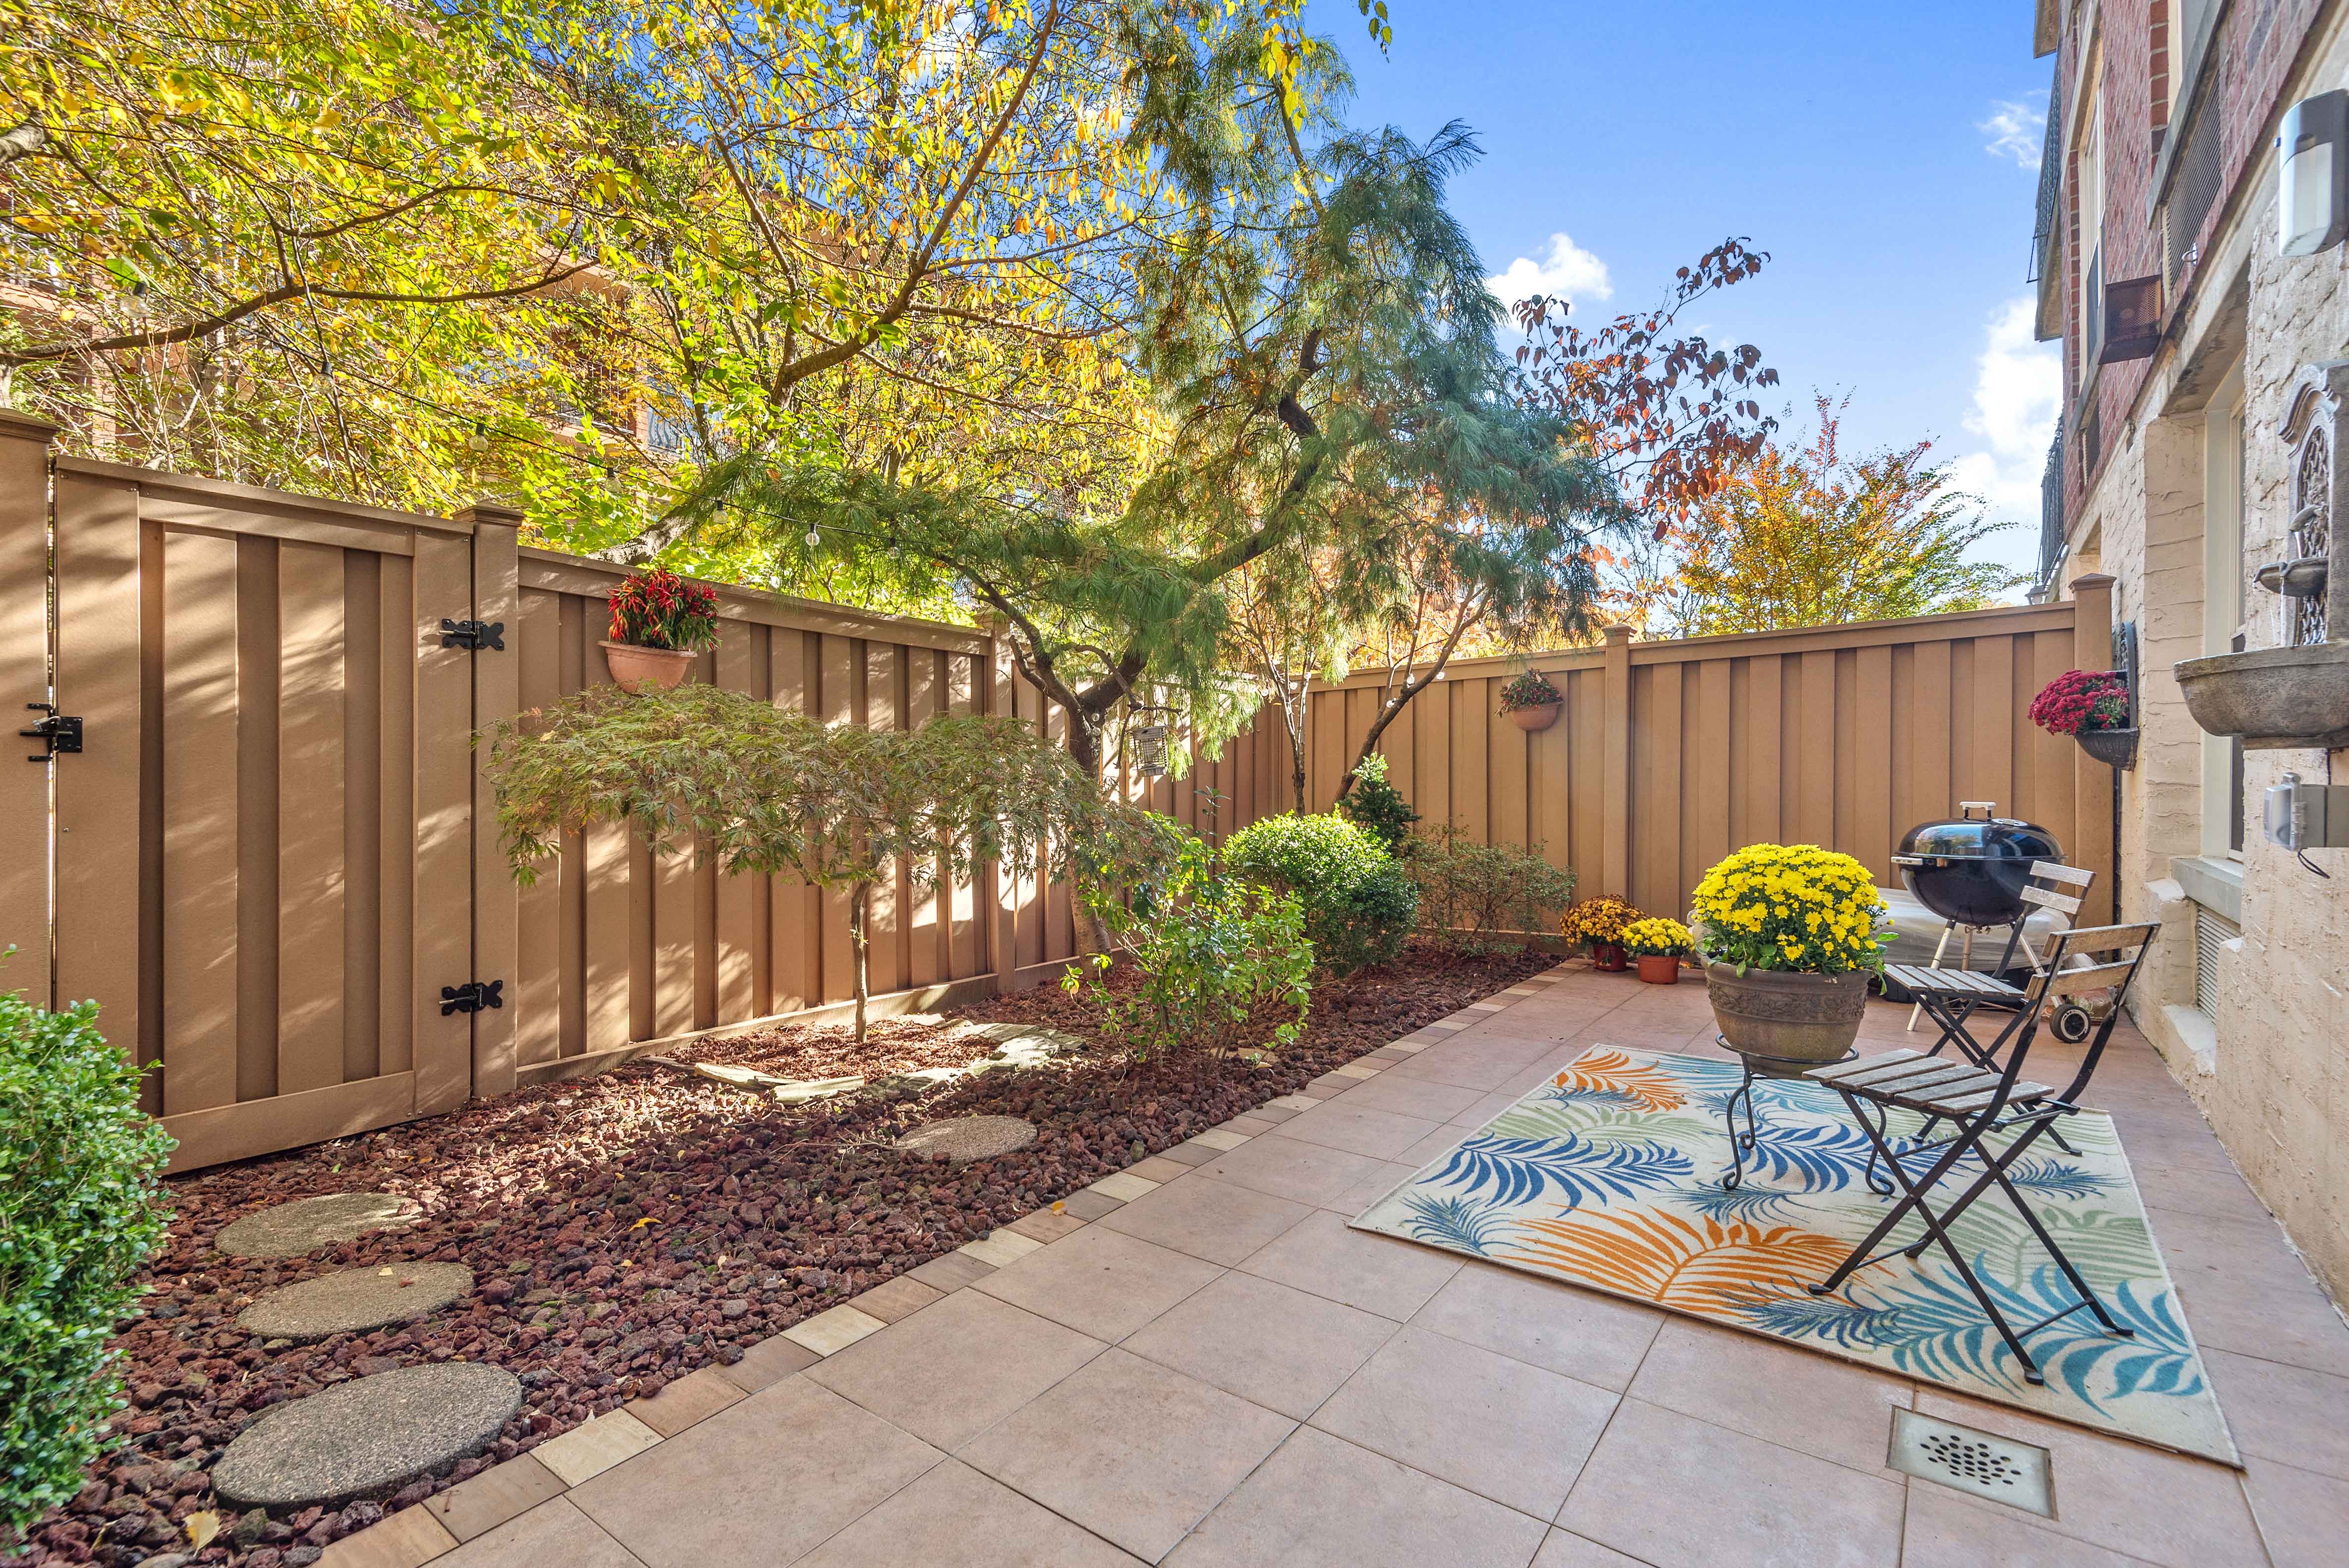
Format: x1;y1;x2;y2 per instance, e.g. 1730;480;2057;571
1804;922;2161;1383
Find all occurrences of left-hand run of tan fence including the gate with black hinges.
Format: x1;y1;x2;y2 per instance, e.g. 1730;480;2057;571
0;415;1090;1169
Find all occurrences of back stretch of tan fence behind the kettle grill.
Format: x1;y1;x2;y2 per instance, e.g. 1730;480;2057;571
1306;603;2112;913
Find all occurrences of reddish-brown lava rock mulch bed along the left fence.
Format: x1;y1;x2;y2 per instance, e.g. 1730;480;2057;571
26;946;1553;1568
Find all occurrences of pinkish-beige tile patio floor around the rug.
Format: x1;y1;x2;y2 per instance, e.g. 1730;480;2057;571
366;965;2349;1568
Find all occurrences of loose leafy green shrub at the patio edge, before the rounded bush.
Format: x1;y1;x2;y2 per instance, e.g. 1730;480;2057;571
1062;836;1313;1061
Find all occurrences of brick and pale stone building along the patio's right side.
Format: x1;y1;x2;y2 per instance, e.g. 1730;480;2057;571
2032;0;2349;1300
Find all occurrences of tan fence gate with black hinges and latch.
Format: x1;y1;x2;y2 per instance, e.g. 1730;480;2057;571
0;410;512;1169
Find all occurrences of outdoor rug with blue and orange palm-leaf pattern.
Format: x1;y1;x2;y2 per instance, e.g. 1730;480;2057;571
1353;1047;2241;1465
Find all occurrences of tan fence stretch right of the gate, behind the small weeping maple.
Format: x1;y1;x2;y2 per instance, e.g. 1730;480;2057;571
505;549;996;1082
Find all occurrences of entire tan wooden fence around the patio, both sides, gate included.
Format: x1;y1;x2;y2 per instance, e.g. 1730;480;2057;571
0;413;2112;1169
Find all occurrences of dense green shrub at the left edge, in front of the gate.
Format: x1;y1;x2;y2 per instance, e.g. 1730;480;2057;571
0;991;171;1542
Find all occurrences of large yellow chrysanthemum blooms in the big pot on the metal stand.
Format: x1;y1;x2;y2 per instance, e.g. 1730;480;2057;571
1696;845;1891;974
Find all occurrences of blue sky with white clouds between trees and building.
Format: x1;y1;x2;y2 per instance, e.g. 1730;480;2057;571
1308;0;2058;566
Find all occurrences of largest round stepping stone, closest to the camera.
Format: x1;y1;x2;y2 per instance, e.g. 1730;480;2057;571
212;1361;521;1510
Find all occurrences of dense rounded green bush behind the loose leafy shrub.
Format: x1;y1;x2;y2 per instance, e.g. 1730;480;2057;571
1224;812;1419;974
